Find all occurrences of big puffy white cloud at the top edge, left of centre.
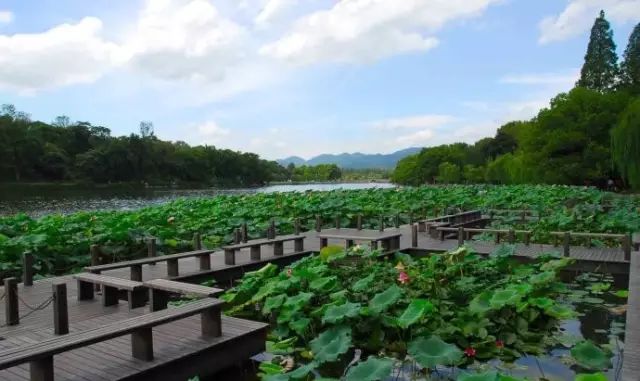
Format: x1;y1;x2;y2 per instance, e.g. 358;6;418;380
125;0;246;83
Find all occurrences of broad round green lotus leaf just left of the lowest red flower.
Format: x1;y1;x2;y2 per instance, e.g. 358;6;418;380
407;336;462;368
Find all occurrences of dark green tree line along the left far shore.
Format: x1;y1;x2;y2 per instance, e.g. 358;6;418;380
0;105;286;185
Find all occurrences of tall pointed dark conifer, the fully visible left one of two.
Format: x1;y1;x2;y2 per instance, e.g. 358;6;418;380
576;11;618;92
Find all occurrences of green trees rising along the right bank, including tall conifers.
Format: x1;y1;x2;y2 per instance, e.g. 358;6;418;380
392;11;640;189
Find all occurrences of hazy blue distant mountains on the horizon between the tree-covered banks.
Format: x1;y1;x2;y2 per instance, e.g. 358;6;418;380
277;147;422;169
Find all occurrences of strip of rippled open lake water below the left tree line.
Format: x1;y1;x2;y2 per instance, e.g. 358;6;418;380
0;183;395;217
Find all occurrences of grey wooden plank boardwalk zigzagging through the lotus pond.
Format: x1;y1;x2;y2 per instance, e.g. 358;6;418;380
0;225;640;381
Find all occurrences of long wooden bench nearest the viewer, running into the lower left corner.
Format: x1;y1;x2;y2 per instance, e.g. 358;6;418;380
0;299;224;381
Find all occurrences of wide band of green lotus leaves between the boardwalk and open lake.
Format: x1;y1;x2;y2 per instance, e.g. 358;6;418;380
0;185;640;274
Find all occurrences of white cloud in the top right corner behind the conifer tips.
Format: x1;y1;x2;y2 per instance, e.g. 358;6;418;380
538;0;640;44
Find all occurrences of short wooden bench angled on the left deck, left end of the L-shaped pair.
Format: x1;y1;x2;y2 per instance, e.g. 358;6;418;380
73;273;147;308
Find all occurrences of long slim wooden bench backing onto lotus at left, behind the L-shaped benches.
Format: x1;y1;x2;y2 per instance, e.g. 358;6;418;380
84;250;214;282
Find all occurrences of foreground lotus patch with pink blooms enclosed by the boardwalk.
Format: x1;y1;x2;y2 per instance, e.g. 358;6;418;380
219;246;627;381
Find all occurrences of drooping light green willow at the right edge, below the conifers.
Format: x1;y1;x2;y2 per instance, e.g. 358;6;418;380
611;98;640;189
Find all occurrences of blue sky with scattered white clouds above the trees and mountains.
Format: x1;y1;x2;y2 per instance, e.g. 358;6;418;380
0;0;640;159
